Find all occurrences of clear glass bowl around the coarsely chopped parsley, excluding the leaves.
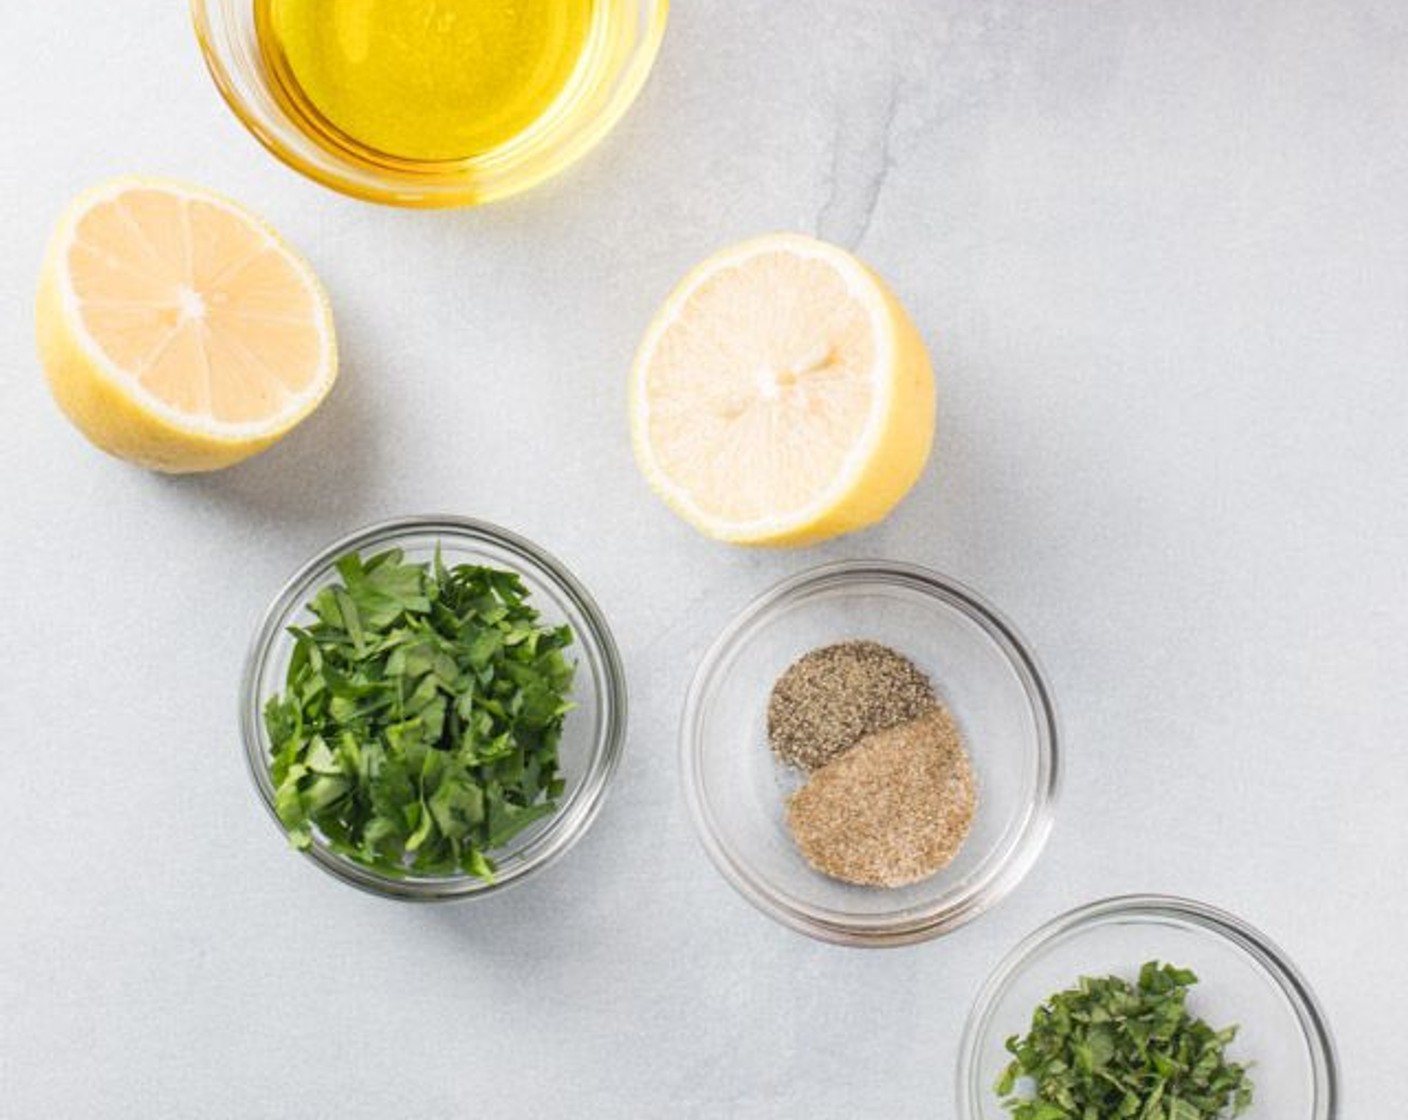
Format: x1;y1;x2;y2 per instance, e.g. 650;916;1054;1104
239;517;627;902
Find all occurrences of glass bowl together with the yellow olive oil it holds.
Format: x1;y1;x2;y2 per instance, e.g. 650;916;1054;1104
191;0;669;207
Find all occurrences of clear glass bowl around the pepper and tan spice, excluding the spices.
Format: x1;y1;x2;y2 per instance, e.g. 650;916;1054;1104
681;561;1057;945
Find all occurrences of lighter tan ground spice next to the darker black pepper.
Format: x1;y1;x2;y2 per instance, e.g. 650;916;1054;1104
787;706;977;886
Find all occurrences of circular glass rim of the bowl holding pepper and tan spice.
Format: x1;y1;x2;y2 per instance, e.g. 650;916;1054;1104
680;559;1062;948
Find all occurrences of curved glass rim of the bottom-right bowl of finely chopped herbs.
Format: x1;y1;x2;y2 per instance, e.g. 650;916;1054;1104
955;895;1340;1120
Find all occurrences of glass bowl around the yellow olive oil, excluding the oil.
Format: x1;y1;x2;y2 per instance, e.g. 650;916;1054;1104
190;0;669;207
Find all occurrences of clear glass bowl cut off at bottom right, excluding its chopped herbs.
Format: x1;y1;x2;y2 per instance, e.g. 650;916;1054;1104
957;895;1339;1120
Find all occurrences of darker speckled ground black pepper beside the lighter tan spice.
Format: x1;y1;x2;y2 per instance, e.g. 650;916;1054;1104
767;641;939;771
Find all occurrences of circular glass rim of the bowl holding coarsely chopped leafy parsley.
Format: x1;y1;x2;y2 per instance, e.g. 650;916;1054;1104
239;514;627;902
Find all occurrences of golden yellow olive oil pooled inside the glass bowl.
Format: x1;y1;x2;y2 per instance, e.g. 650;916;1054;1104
253;0;598;162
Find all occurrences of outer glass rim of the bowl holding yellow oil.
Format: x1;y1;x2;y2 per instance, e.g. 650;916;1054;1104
187;0;670;209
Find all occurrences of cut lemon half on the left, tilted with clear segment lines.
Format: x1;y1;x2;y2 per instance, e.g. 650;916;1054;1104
37;179;337;472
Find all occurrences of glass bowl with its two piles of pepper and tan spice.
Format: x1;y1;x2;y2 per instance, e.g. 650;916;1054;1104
681;561;1059;945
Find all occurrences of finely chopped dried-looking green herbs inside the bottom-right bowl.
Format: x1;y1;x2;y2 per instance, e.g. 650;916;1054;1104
997;961;1252;1120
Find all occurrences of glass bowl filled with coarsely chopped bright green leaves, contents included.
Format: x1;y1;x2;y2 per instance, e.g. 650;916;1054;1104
241;517;625;900
